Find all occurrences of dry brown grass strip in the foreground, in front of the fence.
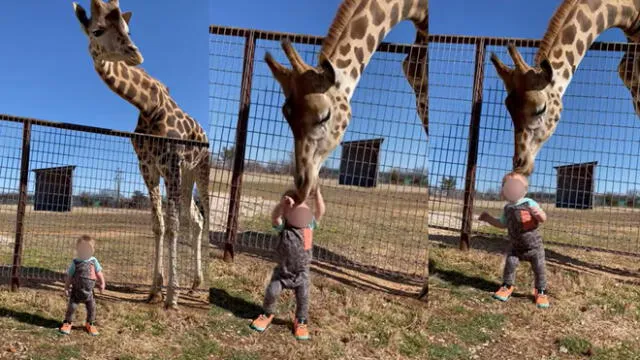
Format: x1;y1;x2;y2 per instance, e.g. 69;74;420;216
0;246;640;360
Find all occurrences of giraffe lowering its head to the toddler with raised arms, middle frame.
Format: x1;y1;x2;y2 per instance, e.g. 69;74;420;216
265;0;429;201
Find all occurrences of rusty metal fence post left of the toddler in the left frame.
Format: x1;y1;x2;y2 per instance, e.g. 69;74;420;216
11;120;31;291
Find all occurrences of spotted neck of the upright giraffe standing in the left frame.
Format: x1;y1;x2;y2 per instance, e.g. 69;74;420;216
94;60;170;115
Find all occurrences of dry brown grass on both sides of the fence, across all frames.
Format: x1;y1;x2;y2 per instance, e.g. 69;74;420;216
0;175;640;360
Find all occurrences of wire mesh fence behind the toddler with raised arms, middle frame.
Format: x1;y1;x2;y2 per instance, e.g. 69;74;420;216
210;27;436;278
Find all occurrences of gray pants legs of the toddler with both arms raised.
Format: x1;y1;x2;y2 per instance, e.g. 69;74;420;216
262;266;309;320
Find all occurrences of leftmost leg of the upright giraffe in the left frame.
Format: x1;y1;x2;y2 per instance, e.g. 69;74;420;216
140;164;164;303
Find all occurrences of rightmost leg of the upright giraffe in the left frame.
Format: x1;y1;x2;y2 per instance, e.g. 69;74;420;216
191;154;211;290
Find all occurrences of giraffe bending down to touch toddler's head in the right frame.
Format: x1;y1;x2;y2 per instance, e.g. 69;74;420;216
491;0;640;176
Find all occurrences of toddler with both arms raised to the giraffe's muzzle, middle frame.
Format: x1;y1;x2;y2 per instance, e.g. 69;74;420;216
251;189;325;340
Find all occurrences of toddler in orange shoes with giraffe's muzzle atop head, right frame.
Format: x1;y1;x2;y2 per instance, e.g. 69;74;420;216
479;172;549;308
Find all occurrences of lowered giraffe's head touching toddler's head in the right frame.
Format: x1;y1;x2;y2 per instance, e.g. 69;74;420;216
491;44;562;176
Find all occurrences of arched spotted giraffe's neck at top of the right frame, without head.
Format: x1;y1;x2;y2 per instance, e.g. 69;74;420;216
536;0;640;96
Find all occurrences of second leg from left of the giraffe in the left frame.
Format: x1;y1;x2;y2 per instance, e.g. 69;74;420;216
164;152;182;309
